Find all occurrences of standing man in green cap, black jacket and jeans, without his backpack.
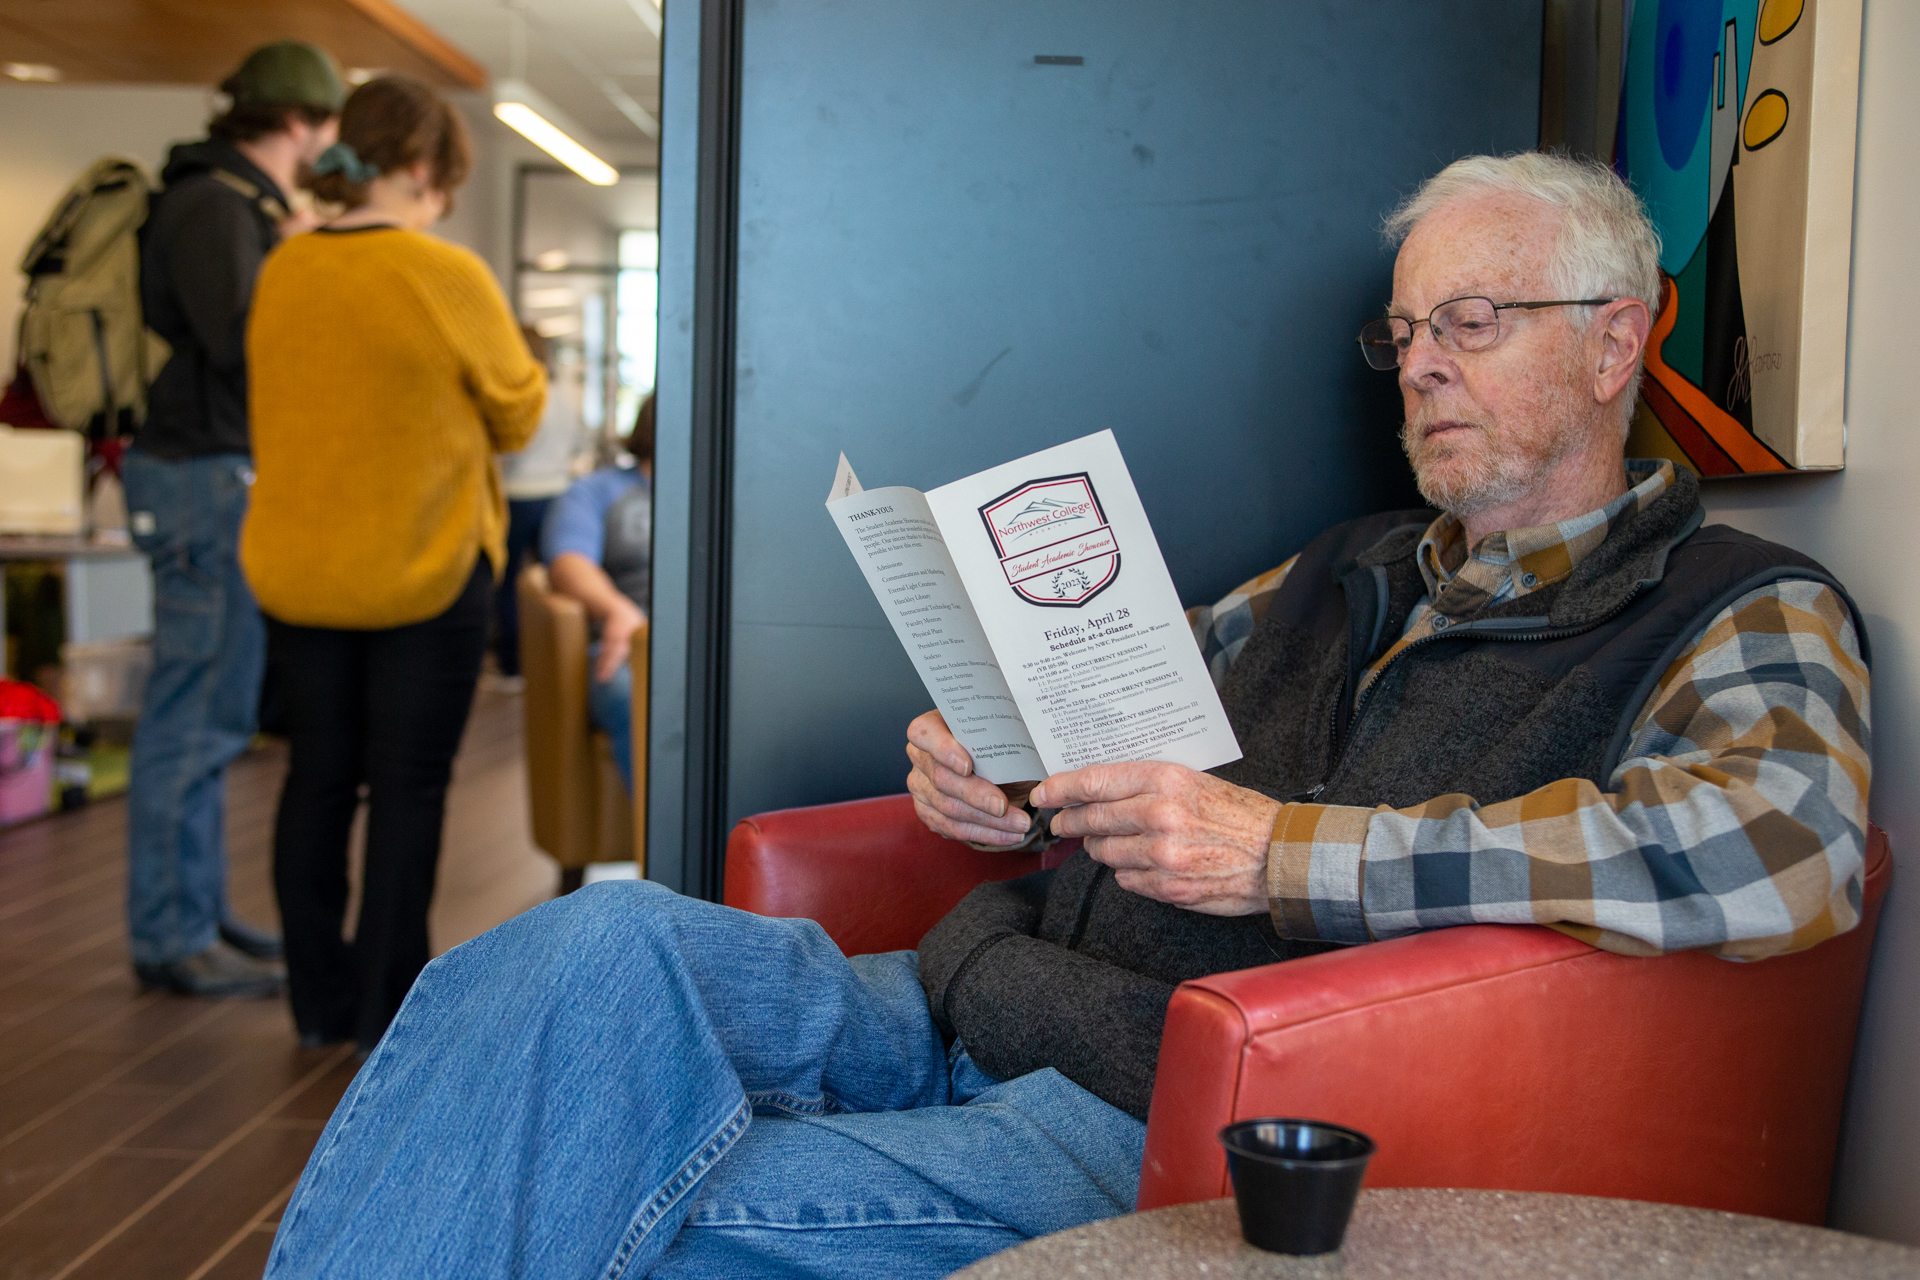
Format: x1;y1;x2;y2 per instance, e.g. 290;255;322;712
123;40;346;996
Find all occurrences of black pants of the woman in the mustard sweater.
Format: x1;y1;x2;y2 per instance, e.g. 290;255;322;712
267;557;493;1046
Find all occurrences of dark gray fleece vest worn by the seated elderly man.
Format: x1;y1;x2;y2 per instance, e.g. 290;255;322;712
922;470;1866;1115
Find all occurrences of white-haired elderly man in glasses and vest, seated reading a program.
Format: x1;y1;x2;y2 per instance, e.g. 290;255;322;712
269;155;1868;1278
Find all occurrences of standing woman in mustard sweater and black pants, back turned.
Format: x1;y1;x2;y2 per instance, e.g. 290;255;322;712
240;77;547;1052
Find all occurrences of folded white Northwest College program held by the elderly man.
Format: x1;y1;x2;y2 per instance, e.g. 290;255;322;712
828;432;1240;783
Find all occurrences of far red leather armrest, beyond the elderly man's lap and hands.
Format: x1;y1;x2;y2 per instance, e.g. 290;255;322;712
724;794;1058;956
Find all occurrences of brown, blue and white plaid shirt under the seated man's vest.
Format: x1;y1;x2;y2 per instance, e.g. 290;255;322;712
1188;462;1872;960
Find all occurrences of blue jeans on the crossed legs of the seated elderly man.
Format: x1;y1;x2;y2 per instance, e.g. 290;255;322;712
267;881;1146;1280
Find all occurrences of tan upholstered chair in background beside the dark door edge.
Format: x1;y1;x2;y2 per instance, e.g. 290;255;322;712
515;564;647;889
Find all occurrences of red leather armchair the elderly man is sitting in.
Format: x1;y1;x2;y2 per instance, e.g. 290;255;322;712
726;796;1893;1222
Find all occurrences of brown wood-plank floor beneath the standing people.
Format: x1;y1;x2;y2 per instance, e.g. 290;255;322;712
0;693;559;1280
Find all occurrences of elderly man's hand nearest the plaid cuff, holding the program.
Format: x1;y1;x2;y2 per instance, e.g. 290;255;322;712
1029;767;1281;915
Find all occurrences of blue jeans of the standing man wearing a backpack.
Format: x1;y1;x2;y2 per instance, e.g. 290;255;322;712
121;449;267;963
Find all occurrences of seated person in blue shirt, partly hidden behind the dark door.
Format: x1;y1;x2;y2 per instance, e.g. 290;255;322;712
540;395;653;791
